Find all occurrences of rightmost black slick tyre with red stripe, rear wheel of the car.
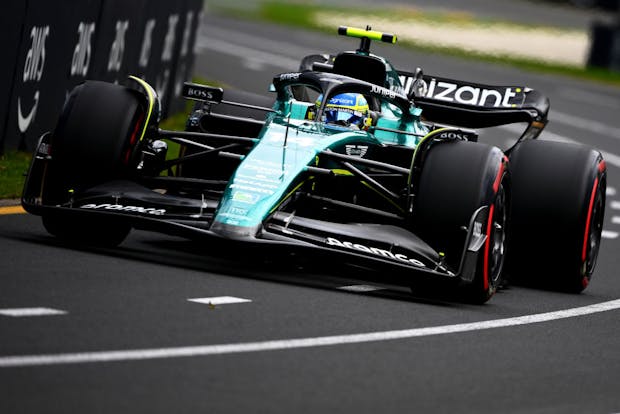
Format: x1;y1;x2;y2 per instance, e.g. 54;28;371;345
507;141;607;293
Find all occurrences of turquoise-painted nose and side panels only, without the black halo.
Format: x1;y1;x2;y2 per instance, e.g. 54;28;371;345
213;100;427;237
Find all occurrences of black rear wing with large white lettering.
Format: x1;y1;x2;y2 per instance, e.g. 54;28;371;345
398;71;549;138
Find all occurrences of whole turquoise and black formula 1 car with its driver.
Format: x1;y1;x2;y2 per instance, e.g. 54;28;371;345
22;27;606;303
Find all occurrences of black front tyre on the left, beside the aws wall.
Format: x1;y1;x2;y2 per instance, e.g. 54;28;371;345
42;81;144;245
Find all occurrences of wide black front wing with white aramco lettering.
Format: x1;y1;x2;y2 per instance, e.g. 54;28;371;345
22;150;487;286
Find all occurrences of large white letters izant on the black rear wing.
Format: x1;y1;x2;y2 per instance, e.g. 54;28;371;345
426;79;523;108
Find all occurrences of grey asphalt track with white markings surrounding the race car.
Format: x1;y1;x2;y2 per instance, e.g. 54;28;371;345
0;8;620;413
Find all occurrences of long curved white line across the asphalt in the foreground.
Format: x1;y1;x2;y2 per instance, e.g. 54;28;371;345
0;299;620;368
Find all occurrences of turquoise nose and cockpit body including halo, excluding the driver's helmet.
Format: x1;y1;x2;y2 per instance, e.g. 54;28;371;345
211;61;429;237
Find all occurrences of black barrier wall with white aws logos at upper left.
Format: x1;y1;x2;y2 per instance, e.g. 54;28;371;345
0;0;203;152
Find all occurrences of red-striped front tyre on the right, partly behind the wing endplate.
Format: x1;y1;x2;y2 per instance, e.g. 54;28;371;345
413;141;510;303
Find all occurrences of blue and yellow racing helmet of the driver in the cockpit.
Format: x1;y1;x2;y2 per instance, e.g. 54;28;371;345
316;93;369;129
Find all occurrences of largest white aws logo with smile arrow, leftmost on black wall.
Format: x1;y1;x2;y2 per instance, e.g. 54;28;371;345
17;26;50;134
